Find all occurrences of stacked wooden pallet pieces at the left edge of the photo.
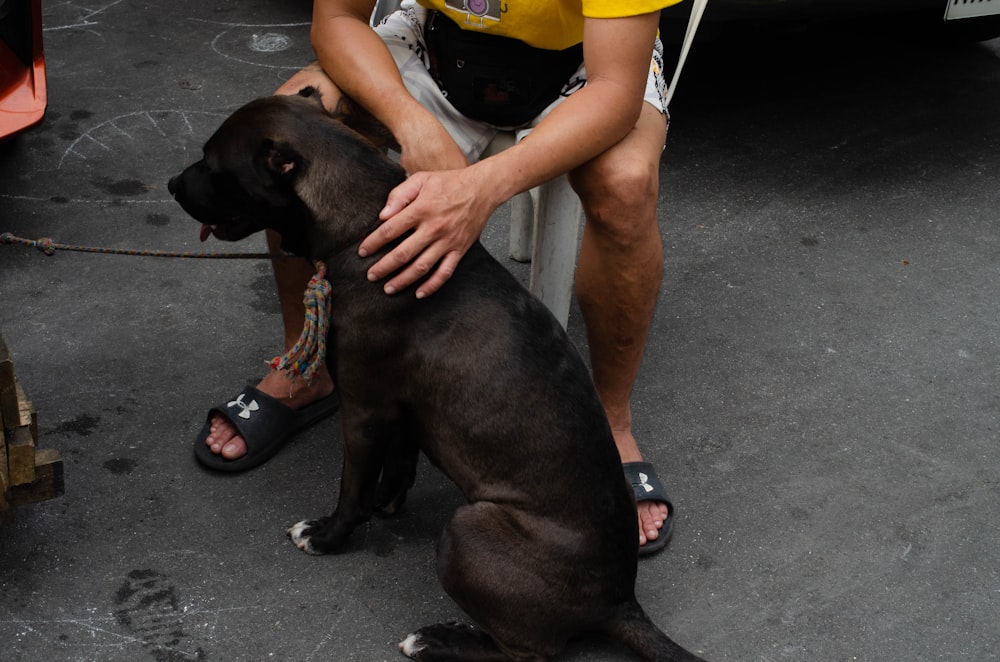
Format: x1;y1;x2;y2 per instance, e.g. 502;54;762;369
0;335;63;523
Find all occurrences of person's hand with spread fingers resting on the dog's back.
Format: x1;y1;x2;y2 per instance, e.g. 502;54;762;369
359;167;497;299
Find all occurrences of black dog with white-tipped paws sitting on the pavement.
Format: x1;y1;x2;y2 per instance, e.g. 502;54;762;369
169;91;699;662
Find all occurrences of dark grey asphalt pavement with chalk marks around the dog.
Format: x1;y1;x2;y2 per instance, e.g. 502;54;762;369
0;0;1000;661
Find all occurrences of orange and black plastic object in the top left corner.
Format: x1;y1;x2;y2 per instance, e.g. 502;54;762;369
0;0;48;139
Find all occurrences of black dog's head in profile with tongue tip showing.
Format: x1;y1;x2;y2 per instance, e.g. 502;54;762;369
168;90;398;255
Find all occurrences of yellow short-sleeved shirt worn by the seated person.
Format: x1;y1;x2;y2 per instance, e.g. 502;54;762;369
418;0;681;50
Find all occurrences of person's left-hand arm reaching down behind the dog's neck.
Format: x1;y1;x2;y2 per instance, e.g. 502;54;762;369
311;0;466;172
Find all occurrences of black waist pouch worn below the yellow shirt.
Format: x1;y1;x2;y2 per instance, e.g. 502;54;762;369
424;12;583;127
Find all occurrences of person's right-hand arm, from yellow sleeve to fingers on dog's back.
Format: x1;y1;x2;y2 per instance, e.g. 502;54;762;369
361;12;659;297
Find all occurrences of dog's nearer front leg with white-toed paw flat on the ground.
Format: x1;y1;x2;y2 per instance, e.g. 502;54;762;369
288;411;395;554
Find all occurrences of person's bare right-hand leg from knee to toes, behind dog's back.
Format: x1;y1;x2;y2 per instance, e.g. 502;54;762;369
570;104;667;544
